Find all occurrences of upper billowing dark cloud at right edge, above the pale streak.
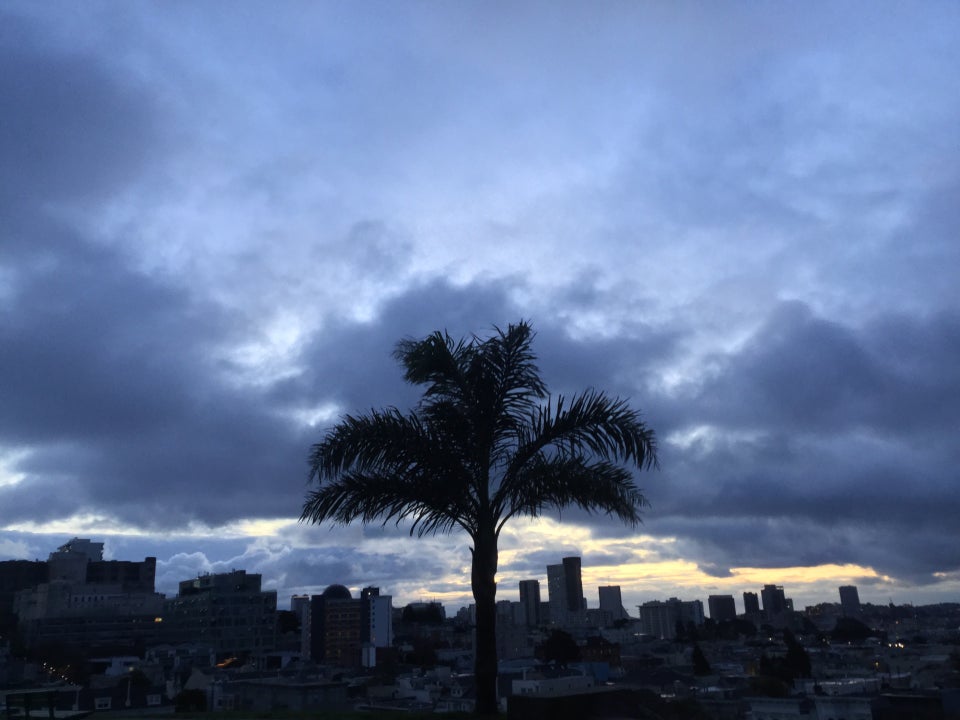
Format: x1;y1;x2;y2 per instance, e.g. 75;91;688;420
692;302;960;436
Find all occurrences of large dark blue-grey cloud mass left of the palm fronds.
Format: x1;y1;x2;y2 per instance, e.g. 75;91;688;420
0;222;303;527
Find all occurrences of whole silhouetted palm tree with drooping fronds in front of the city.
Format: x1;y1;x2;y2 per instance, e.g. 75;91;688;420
300;322;657;715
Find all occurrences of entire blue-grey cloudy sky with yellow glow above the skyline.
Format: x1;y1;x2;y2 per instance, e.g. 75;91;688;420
0;0;960;611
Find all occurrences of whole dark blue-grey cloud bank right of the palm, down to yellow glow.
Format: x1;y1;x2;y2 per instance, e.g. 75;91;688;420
651;304;960;578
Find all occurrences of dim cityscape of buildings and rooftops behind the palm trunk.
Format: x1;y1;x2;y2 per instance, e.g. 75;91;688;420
0;538;960;720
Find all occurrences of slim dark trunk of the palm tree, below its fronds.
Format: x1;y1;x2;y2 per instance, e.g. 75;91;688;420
471;527;499;715
